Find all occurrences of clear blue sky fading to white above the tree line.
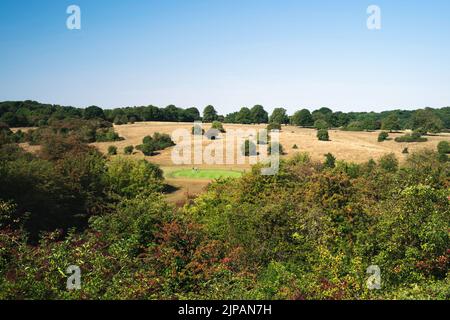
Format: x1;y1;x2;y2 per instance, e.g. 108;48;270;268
0;0;450;114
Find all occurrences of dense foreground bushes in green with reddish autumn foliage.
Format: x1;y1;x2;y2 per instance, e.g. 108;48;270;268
0;139;450;300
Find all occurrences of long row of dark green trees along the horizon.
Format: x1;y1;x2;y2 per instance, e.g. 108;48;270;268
0;101;450;133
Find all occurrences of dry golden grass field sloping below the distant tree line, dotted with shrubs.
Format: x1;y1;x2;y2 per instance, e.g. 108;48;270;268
88;122;450;203
